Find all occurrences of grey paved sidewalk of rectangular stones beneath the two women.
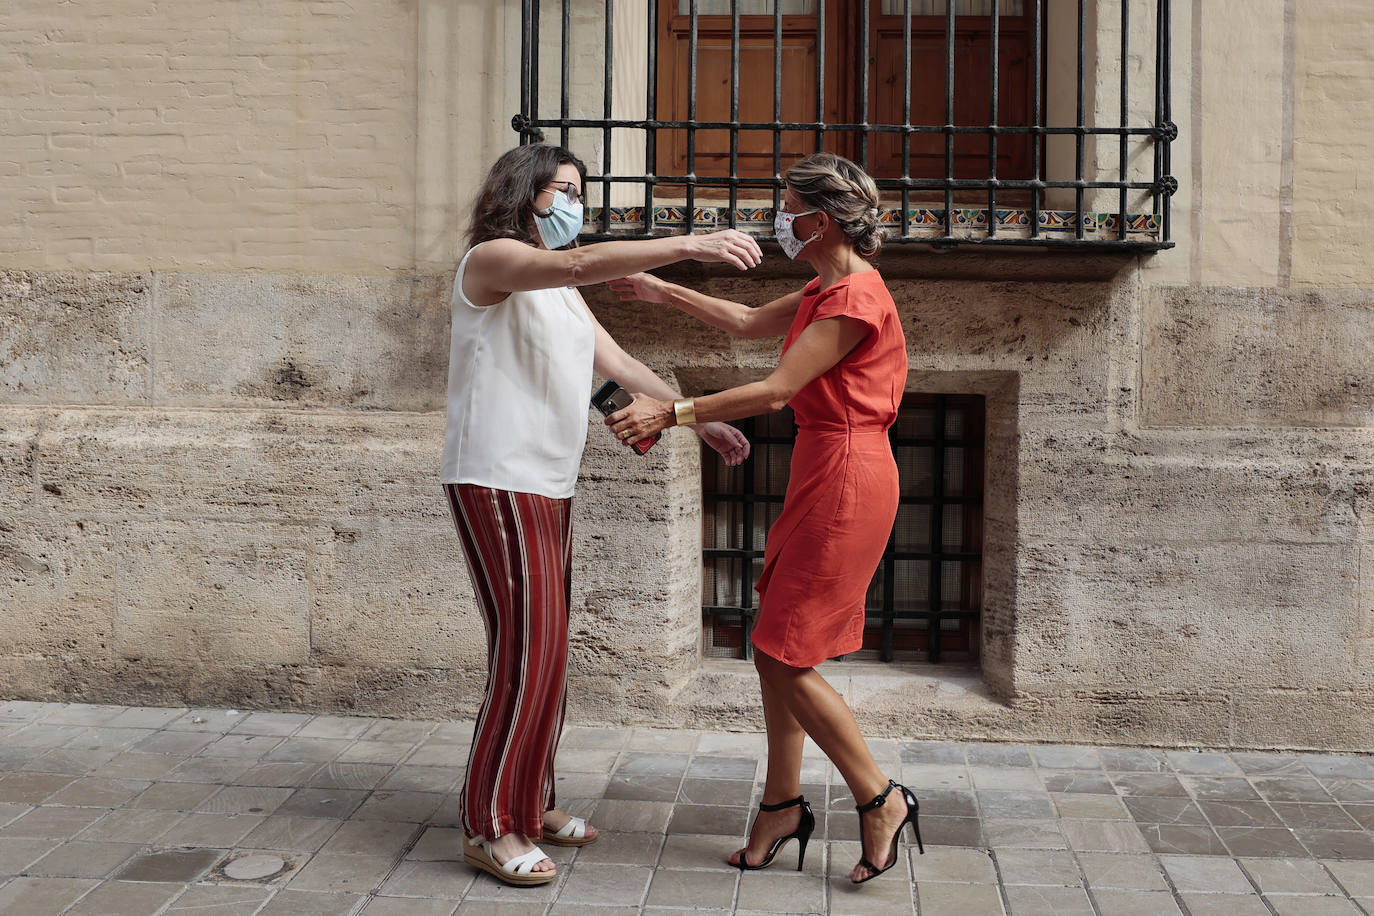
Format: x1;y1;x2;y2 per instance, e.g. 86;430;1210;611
0;702;1374;916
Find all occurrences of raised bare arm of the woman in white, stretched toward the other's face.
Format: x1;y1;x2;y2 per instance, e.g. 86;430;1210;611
463;229;763;305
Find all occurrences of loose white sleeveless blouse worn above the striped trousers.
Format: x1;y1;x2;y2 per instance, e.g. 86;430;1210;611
440;246;596;499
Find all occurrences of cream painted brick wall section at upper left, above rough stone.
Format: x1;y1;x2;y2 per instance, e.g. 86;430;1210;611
0;0;519;275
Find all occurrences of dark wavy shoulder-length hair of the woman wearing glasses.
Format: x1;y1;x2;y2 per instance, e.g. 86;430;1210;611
467;143;587;247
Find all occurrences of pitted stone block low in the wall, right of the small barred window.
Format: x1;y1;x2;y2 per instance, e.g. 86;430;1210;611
1015;540;1359;694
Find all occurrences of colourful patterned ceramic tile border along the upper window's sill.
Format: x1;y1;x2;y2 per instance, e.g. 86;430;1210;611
584;205;1160;242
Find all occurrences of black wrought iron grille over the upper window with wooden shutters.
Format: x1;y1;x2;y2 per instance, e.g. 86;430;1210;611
511;0;1178;250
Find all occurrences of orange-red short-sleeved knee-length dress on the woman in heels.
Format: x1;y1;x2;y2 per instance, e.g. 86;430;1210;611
753;271;907;667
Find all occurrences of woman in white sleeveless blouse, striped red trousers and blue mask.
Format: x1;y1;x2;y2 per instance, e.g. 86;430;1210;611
441;144;761;884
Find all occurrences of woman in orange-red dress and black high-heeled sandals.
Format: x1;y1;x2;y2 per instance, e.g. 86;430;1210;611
606;152;925;883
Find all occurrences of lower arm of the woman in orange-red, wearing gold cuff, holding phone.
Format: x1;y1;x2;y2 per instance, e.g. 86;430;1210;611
606;316;868;445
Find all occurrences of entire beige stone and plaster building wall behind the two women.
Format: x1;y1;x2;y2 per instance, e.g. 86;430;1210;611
0;0;1374;750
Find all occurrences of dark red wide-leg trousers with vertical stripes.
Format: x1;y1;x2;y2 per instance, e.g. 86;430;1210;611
444;483;573;839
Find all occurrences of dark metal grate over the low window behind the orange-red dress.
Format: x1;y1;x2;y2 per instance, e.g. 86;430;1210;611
702;394;984;662
